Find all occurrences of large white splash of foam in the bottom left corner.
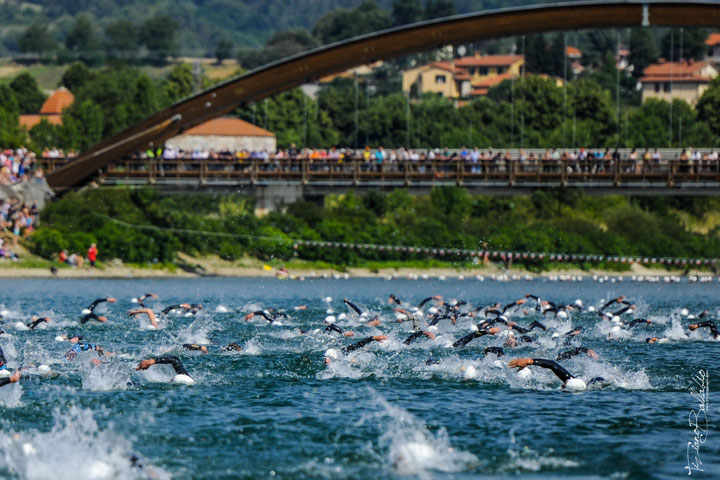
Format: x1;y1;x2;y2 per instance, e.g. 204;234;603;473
0;406;170;480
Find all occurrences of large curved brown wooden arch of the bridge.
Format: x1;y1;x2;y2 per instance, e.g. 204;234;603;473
47;1;720;193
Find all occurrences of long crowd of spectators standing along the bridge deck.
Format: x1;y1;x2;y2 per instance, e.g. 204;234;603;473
128;145;720;178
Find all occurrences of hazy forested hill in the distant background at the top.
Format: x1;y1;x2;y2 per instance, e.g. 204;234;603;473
0;0;564;56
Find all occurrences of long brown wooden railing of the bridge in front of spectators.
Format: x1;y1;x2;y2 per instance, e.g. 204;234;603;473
44;156;720;186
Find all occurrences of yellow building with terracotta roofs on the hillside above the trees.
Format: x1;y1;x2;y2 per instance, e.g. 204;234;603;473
402;55;525;99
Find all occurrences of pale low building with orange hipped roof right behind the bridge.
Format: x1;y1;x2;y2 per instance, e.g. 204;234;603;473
165;117;277;152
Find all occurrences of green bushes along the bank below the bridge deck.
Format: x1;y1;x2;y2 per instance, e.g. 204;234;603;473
31;187;720;269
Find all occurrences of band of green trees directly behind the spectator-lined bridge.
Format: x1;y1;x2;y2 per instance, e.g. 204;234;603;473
0;58;720;150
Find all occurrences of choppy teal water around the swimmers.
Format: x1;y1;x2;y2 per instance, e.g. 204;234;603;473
0;279;720;479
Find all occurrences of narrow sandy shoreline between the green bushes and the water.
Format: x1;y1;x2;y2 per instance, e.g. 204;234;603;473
0;257;720;282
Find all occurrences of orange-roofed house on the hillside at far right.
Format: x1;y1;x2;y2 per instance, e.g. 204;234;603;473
640;59;720;105
